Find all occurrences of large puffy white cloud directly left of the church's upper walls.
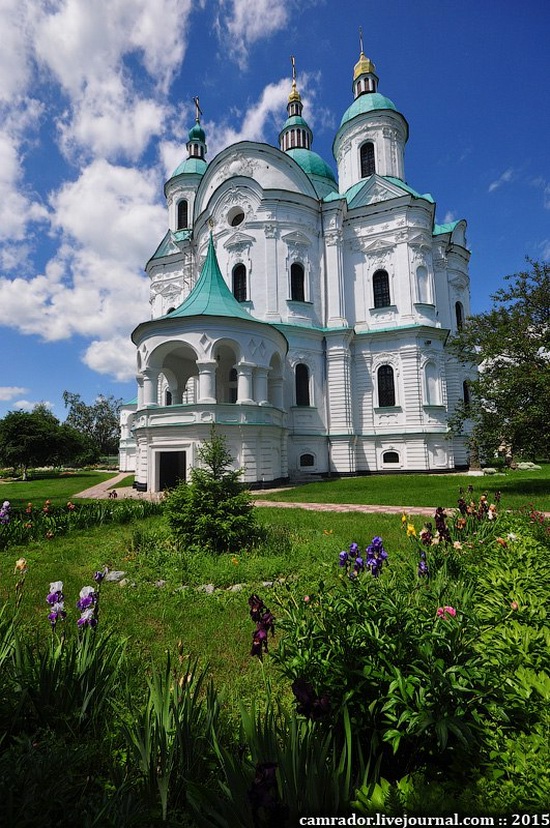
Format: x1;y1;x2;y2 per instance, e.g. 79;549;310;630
0;160;166;341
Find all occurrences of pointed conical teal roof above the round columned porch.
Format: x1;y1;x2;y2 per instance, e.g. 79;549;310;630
164;234;258;322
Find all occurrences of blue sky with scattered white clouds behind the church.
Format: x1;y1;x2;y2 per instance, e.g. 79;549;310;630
0;0;550;419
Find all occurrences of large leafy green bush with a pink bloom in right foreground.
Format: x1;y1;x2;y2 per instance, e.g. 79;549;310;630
272;501;550;783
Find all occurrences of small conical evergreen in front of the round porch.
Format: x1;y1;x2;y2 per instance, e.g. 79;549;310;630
164;428;259;554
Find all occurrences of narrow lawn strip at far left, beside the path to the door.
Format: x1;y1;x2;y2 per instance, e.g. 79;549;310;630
0;471;120;509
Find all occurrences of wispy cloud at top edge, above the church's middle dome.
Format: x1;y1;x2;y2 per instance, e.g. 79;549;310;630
217;0;293;69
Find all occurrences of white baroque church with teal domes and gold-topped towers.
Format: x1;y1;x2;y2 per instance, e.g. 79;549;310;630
120;49;470;492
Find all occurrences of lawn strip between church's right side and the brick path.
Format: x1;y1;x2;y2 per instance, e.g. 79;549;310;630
260;464;550;511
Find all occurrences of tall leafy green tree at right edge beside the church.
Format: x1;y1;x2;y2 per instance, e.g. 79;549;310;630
451;259;550;459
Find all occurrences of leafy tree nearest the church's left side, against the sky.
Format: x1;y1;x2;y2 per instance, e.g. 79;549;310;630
63;391;122;454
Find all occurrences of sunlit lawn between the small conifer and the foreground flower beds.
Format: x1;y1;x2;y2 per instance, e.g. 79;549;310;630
0;508;410;716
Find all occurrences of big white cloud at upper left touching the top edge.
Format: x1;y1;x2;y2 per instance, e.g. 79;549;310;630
35;0;193;161
